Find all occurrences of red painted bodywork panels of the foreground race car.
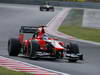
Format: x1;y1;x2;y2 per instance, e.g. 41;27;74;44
19;26;64;54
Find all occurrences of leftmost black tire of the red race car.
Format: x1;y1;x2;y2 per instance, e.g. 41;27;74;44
8;38;21;56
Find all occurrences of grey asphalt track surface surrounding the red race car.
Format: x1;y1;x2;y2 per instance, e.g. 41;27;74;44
0;4;100;75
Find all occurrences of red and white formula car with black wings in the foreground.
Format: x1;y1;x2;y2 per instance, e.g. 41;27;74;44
8;26;83;62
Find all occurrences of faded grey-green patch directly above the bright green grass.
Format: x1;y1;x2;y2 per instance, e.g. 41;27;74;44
63;9;84;26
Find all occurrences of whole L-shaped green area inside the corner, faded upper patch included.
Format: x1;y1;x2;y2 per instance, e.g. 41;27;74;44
59;9;100;42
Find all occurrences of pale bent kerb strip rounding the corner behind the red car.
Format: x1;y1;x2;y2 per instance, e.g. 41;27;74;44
46;8;75;40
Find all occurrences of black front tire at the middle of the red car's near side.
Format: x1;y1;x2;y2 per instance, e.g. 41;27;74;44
29;41;40;59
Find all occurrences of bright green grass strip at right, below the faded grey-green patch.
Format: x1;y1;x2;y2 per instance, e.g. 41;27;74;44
59;25;100;42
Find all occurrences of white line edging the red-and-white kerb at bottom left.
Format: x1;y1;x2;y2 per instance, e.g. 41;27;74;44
0;56;70;75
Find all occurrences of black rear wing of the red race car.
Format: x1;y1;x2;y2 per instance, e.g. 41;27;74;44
19;26;39;33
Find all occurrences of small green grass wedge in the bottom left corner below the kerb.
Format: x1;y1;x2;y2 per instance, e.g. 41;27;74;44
0;67;32;75
